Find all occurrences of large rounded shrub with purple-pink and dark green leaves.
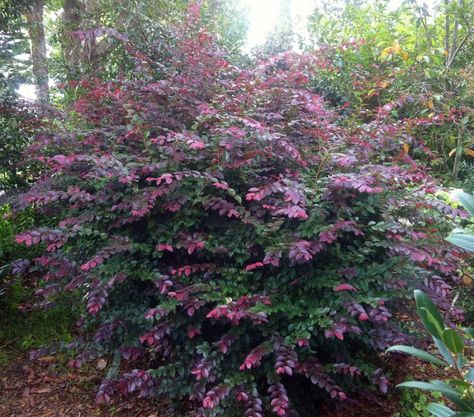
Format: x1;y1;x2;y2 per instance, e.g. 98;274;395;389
15;13;463;417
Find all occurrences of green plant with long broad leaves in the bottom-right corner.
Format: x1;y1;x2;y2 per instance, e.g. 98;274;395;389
388;290;474;417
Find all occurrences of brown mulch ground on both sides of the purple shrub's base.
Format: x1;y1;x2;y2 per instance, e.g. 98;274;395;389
0;352;446;417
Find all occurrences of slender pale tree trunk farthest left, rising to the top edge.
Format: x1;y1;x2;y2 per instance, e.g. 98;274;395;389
26;0;49;103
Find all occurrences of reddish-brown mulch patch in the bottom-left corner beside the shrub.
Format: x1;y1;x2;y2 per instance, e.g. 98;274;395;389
0;353;164;417
